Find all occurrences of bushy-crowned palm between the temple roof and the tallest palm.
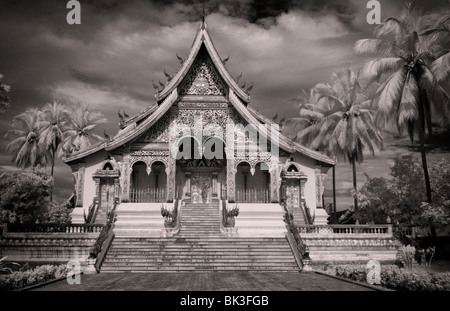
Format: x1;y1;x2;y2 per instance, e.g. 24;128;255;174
302;69;382;211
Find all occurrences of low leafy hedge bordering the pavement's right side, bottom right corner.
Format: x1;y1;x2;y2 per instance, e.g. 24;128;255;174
335;265;450;291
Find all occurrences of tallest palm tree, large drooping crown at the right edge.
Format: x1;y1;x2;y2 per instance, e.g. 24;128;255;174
355;3;450;217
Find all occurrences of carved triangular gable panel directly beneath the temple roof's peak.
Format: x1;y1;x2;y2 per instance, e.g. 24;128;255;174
180;48;225;95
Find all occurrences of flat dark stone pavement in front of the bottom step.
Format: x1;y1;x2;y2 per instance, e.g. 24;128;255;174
29;272;374;291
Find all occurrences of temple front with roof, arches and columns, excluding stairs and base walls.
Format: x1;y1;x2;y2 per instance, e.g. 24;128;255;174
64;22;335;232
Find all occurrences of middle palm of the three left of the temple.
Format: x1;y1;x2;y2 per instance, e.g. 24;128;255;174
39;102;70;177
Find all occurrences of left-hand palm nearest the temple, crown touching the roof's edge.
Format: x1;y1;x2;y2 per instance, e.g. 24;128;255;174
62;105;108;153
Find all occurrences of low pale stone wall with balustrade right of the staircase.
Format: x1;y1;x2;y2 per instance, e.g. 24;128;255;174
298;225;401;265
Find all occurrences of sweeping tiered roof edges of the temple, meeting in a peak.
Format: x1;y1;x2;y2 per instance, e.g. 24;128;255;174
63;22;336;165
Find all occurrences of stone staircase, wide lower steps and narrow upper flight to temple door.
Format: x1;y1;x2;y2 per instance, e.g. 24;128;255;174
101;203;299;273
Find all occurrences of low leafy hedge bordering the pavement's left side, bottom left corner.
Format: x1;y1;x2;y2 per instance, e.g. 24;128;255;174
0;265;68;291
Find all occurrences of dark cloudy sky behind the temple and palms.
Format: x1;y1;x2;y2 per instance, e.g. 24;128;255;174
0;0;448;209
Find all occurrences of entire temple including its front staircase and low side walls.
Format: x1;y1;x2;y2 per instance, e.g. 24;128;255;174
0;21;400;274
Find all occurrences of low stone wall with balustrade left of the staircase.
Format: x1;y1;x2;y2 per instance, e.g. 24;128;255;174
0;233;99;264
